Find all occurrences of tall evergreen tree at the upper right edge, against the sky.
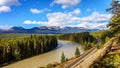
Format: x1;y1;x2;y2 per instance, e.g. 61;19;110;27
107;0;120;35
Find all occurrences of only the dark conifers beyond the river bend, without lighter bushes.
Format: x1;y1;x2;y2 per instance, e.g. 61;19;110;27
58;32;95;44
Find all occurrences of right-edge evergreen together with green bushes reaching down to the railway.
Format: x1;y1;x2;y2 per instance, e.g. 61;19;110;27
92;0;120;48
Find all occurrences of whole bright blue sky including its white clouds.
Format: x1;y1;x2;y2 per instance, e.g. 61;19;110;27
0;0;112;29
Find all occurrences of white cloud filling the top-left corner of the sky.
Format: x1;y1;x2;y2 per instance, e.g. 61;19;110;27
0;0;20;13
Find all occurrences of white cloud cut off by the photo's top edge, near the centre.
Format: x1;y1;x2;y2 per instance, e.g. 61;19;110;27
51;0;80;9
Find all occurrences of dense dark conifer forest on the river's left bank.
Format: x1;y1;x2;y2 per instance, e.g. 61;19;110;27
0;35;57;65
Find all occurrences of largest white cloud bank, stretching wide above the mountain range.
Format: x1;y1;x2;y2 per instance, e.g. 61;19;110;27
24;9;111;29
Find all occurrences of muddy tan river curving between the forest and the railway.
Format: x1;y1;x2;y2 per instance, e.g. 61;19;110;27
3;40;84;68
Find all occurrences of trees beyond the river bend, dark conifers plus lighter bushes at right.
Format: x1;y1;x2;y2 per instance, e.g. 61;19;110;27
58;32;97;50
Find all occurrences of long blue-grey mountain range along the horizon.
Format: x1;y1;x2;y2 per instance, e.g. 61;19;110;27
0;26;99;34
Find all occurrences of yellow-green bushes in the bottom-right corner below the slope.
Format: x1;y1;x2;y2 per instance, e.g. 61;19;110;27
94;54;120;68
